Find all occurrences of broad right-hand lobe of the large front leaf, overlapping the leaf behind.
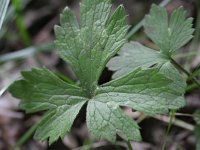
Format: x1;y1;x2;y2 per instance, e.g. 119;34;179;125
95;69;185;114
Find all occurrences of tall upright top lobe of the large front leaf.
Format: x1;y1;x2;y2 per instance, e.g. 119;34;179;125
55;0;128;96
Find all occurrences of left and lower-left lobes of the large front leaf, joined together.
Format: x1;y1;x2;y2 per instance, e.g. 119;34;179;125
9;69;87;144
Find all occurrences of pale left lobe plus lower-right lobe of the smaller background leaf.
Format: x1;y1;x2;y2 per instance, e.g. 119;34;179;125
107;42;186;94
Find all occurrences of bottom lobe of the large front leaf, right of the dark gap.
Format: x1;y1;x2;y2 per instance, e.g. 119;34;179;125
87;101;141;142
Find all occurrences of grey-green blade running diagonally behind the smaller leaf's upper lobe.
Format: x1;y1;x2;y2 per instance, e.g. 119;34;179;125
126;0;171;39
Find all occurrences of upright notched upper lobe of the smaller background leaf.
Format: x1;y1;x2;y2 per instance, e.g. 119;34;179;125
144;5;194;56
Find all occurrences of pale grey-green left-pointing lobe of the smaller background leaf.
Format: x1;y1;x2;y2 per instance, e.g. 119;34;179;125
107;42;168;79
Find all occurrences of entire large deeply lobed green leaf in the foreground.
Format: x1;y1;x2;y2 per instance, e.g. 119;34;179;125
9;0;188;144
